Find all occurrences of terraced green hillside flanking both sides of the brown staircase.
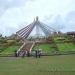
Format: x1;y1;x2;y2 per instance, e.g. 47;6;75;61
0;36;75;56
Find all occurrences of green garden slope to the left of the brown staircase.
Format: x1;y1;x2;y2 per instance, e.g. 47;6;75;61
0;40;22;56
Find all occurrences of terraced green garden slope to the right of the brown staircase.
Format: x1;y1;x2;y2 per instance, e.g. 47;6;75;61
33;37;75;54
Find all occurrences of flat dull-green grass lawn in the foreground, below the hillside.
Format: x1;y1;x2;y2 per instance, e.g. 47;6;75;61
0;55;75;75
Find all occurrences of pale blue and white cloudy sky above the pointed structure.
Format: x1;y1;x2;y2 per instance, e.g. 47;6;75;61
0;0;75;35
